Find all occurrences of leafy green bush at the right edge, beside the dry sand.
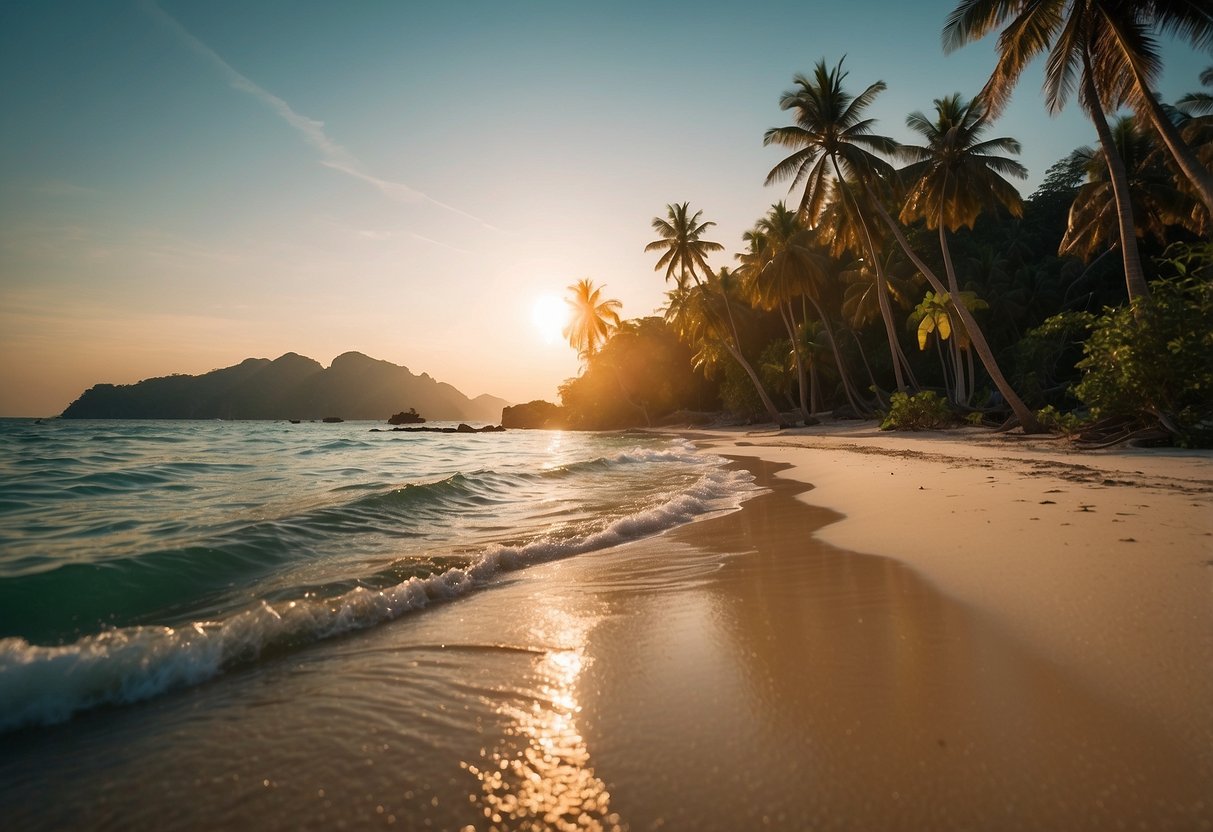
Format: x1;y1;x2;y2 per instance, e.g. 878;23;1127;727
1075;252;1213;446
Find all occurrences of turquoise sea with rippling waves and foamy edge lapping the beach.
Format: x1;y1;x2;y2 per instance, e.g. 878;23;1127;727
0;420;754;730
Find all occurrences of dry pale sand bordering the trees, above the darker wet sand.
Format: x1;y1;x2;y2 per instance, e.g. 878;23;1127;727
706;426;1213;757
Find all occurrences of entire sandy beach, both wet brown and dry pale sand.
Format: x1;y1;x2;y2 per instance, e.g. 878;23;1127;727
0;423;1213;831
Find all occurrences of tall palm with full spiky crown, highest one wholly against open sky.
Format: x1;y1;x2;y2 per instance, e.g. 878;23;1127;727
763;59;905;391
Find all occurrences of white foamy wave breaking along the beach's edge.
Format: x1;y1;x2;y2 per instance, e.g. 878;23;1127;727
0;458;756;731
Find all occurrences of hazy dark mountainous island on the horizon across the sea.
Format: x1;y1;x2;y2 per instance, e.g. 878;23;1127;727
63;353;508;422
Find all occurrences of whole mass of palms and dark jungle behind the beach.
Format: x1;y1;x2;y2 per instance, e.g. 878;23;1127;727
560;8;1213;445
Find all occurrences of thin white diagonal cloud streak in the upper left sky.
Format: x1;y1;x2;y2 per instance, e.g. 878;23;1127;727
143;0;500;230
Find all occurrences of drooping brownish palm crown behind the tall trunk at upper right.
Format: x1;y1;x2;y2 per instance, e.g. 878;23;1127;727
1059;116;1197;262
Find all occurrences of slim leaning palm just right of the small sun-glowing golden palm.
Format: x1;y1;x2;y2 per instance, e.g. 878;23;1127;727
644;203;784;427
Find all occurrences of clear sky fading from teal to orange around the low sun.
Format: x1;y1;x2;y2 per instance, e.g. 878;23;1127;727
0;0;1213;416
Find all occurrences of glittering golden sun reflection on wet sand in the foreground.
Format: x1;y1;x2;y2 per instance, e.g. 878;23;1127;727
462;609;622;832
